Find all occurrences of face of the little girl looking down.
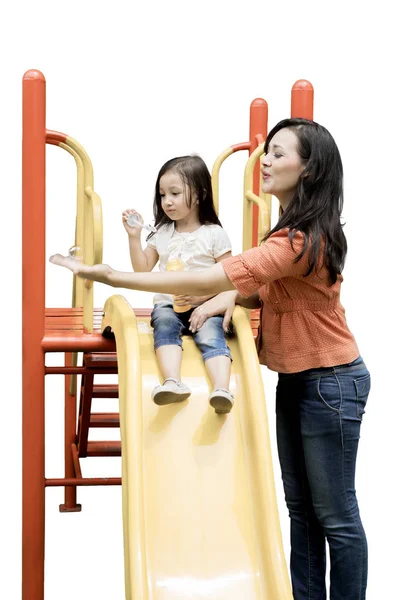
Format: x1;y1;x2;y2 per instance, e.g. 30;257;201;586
159;171;199;223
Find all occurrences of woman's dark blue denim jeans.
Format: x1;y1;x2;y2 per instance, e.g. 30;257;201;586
276;358;371;600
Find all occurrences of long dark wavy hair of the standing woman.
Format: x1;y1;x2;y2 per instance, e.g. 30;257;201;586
263;119;347;285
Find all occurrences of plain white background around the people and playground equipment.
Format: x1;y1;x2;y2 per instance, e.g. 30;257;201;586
0;0;400;600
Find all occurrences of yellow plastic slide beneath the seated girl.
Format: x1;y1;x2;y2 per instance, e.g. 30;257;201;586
103;296;292;600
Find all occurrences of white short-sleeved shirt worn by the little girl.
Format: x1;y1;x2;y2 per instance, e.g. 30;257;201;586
147;223;232;304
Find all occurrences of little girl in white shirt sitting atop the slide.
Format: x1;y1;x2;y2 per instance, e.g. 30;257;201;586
122;156;233;413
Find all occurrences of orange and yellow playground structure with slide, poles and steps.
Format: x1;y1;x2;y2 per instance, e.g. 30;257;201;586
22;70;313;600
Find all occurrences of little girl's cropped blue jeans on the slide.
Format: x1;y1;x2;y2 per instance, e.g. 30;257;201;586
150;302;231;361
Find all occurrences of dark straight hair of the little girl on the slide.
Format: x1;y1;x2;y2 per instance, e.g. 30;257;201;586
147;155;221;239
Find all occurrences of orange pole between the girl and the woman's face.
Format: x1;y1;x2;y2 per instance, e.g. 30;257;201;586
249;98;268;246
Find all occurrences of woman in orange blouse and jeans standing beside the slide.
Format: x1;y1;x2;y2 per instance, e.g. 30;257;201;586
50;119;370;600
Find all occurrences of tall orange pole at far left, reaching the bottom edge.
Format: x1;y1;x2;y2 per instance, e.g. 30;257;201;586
22;70;46;600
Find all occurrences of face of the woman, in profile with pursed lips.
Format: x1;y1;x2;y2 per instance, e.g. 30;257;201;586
261;128;305;210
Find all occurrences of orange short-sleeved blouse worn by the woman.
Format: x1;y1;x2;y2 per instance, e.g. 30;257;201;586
221;229;359;373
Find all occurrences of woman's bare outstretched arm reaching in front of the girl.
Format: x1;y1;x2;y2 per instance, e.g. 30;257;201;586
50;254;235;296
